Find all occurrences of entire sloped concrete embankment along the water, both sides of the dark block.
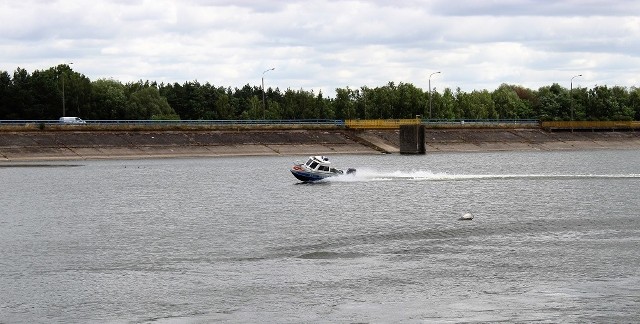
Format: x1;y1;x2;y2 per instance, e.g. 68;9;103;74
0;129;640;161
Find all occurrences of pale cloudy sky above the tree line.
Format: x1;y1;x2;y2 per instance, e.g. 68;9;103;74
0;0;640;97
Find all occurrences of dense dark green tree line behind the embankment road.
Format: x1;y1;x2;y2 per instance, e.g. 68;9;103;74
0;64;640;121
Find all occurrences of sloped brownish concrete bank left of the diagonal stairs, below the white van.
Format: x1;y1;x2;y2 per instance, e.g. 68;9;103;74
0;130;378;161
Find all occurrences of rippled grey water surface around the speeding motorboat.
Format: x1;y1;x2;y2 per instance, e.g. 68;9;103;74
0;150;640;323
